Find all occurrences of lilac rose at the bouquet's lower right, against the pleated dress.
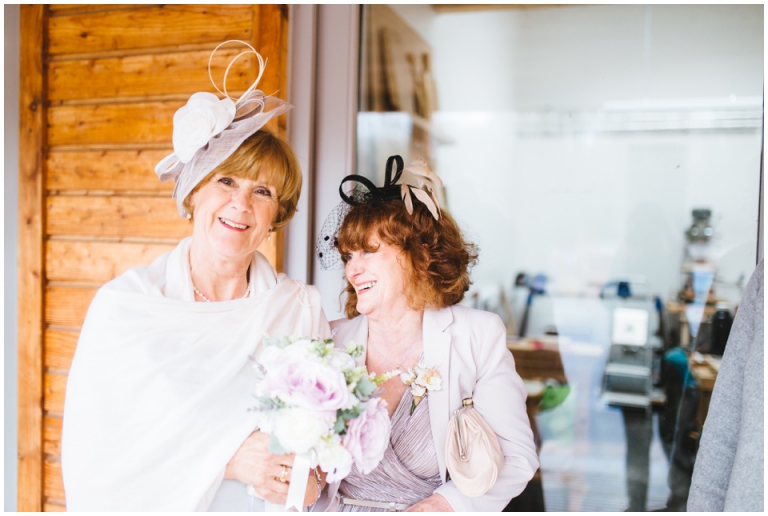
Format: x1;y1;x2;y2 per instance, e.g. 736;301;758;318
342;398;391;475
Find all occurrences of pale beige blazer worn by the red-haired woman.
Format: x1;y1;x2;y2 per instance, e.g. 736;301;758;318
314;305;539;511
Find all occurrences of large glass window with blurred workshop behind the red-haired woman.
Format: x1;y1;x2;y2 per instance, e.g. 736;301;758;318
357;5;763;511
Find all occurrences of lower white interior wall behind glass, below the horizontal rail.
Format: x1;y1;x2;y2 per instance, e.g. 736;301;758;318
438;115;761;301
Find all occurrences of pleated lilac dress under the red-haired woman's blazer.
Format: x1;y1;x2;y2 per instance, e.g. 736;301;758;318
336;390;442;512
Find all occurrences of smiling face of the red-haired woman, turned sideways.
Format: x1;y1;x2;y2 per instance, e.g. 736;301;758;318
344;237;409;319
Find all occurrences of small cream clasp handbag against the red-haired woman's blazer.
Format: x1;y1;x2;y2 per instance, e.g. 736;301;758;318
445;398;504;497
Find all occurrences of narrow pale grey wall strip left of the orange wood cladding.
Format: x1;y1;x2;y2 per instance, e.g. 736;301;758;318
3;5;20;512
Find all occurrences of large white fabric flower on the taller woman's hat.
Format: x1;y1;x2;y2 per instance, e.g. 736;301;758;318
173;92;236;163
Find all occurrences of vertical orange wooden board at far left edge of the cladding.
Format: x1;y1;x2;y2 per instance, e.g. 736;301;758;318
17;5;46;511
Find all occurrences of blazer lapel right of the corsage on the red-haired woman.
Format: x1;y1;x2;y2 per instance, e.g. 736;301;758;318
422;307;453;482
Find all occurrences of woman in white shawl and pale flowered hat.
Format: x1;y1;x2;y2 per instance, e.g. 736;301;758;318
62;42;329;511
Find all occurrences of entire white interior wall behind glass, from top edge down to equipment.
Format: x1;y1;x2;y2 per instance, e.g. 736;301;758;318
395;5;763;301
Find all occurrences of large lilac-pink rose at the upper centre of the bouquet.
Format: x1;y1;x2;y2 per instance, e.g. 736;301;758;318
260;353;356;414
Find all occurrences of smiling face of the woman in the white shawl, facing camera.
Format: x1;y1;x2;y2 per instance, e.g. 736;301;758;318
191;173;278;261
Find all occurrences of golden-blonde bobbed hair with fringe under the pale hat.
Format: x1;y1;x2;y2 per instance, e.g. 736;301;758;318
183;129;301;230
